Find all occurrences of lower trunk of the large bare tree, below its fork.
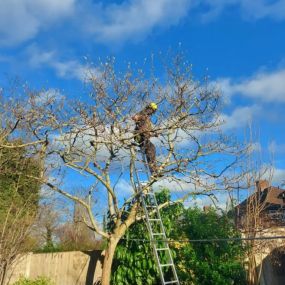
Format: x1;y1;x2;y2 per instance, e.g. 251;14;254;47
101;237;120;285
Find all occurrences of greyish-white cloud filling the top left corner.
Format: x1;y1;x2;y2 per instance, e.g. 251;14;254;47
0;0;75;46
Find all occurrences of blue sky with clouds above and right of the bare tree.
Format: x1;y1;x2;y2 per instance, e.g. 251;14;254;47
0;0;285;190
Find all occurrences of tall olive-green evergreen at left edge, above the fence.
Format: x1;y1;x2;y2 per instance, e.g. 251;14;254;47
0;142;40;284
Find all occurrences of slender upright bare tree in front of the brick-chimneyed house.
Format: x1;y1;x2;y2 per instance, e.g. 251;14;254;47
236;136;278;285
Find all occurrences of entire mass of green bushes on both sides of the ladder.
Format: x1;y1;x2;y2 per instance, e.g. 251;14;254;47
112;190;246;285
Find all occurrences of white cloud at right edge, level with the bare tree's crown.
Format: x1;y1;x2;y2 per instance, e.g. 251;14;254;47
218;69;285;103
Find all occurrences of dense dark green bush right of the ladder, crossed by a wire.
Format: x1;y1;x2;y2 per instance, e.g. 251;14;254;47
175;208;246;285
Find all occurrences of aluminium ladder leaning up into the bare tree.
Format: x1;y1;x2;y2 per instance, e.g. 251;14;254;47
134;153;180;285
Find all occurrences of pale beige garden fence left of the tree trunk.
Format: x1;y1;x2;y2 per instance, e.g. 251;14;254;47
6;250;102;285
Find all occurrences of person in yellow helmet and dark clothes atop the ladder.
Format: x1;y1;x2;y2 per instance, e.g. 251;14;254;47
132;103;157;176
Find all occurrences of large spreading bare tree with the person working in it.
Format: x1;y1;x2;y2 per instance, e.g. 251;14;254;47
5;55;240;285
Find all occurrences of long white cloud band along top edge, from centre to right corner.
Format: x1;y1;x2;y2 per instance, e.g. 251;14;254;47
79;0;285;44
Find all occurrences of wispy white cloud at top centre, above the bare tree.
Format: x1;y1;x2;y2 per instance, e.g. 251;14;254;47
76;0;193;43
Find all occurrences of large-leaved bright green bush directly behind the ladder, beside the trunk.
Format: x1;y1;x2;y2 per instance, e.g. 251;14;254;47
111;190;183;285
